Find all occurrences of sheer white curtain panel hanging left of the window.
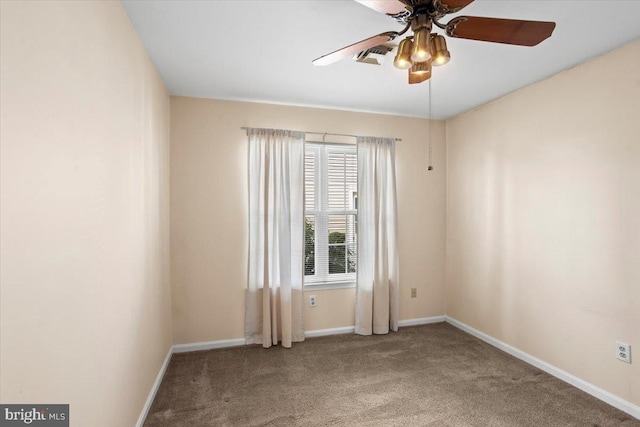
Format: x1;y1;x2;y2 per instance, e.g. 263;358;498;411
245;129;304;348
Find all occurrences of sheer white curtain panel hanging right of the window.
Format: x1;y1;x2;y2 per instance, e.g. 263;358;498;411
356;137;399;335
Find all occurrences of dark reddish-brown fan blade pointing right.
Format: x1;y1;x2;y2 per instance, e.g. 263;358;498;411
447;16;556;46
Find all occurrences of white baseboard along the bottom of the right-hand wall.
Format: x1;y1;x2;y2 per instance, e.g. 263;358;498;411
446;316;640;419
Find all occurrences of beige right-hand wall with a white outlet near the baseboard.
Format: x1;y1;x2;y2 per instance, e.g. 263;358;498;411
447;41;640;405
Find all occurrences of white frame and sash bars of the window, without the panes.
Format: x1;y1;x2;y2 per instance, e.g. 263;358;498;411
304;141;358;290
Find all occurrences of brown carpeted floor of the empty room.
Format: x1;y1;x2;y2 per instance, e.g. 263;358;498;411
144;323;640;427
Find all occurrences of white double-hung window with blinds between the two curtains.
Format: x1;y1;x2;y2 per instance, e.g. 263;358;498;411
304;143;358;285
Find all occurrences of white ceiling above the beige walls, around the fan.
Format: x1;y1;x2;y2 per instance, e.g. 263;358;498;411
122;0;640;119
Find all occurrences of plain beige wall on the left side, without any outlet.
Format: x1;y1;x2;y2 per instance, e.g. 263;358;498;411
0;1;171;427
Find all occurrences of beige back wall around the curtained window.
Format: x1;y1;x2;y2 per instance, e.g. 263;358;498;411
171;96;445;344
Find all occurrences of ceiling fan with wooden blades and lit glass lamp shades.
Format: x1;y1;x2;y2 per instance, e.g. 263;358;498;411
313;0;556;84
